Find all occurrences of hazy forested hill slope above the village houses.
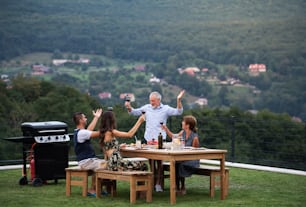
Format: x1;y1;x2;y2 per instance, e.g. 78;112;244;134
0;0;306;70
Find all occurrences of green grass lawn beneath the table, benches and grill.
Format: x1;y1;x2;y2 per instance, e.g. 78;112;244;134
0;168;306;207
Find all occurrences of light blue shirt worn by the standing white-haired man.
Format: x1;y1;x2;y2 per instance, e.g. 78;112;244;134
129;103;183;141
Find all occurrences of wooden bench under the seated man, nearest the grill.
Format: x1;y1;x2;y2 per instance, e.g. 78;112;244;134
65;166;116;197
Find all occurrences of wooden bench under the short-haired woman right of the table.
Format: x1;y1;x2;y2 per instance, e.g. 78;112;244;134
162;162;229;198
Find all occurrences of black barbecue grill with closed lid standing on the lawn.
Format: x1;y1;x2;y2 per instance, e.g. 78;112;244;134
6;121;70;186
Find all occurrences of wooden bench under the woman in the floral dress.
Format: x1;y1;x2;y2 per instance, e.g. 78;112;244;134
95;170;152;203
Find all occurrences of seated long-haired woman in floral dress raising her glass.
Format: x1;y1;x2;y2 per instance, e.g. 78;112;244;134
99;111;148;171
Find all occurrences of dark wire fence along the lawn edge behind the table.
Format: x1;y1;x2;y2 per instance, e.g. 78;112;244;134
0;116;306;171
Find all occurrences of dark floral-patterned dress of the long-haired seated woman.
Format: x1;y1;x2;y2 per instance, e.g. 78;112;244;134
102;138;148;171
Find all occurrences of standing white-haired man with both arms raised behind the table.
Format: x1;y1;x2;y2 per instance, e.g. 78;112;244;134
125;90;185;192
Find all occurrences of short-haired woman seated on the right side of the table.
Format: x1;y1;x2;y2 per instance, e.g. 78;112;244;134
162;115;200;195
